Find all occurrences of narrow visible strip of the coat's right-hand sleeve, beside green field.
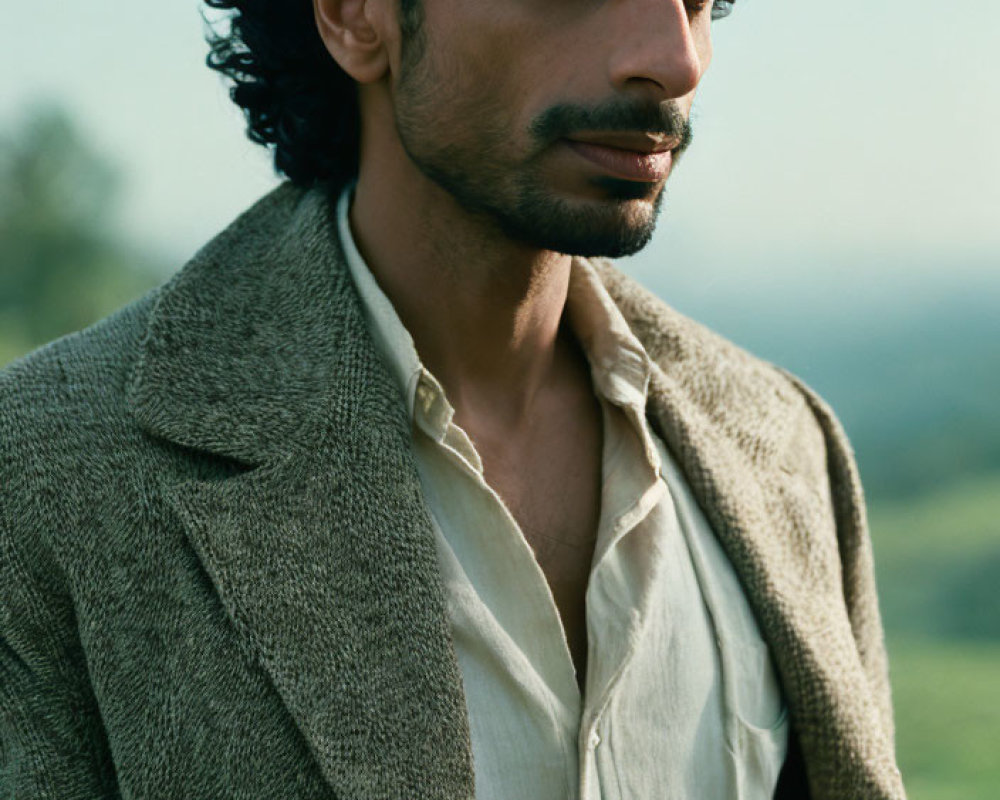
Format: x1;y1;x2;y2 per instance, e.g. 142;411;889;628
785;373;895;747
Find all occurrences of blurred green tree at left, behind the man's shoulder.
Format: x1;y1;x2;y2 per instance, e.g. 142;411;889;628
0;108;156;364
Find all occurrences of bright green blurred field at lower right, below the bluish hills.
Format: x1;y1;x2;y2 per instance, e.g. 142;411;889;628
870;475;1000;800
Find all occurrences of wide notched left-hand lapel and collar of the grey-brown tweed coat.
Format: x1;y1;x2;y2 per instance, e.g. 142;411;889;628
132;186;473;800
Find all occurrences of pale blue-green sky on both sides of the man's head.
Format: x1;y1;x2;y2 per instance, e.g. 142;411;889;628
0;0;1000;300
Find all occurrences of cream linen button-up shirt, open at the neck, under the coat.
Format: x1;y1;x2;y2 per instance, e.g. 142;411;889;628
338;184;788;800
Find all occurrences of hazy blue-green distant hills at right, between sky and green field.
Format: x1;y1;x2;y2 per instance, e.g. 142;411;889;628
642;262;1000;504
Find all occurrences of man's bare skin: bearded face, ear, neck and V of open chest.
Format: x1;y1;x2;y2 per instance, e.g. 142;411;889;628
314;0;711;660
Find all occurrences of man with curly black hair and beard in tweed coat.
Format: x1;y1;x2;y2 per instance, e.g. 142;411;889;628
0;0;903;800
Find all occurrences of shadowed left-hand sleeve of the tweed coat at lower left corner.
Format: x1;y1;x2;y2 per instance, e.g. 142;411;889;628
0;416;117;800
